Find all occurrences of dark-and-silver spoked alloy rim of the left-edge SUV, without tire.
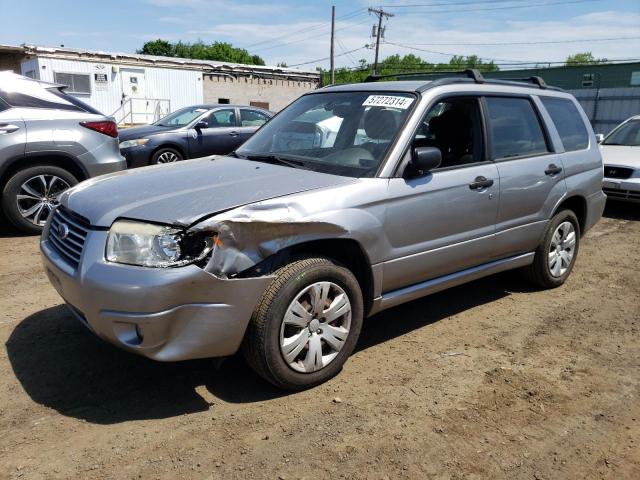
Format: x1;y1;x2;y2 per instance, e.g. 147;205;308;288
16;174;70;227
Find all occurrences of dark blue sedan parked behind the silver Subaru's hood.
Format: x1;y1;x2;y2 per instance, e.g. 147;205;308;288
120;105;273;168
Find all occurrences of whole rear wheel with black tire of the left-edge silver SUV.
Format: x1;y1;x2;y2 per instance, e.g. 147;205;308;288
2;165;78;234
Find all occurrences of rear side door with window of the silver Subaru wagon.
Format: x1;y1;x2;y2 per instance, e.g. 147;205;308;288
484;96;566;258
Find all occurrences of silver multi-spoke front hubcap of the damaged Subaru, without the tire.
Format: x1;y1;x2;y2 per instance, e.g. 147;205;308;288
280;282;351;373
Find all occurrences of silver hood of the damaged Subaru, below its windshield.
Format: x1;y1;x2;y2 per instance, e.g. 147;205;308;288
60;157;355;227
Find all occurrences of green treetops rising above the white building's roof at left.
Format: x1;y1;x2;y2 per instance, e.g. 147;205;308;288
138;39;264;65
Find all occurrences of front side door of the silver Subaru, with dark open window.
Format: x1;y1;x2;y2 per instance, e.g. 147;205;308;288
383;97;500;293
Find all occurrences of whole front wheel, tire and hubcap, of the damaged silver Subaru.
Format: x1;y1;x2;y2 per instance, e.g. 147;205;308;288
242;258;363;390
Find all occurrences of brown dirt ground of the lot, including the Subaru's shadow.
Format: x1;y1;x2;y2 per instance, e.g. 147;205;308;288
0;205;640;480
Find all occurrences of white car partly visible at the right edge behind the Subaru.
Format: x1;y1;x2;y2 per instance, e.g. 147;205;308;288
600;115;640;202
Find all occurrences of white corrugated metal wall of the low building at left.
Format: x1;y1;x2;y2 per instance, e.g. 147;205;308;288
21;56;203;119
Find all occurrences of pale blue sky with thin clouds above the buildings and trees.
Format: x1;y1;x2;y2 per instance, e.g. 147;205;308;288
0;0;640;70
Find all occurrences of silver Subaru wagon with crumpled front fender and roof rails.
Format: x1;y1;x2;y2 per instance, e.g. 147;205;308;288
41;71;606;389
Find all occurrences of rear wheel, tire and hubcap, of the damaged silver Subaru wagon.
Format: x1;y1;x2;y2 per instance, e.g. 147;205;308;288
525;210;580;288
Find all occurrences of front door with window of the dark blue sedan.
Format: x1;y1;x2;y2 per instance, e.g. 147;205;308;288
188;107;242;158
